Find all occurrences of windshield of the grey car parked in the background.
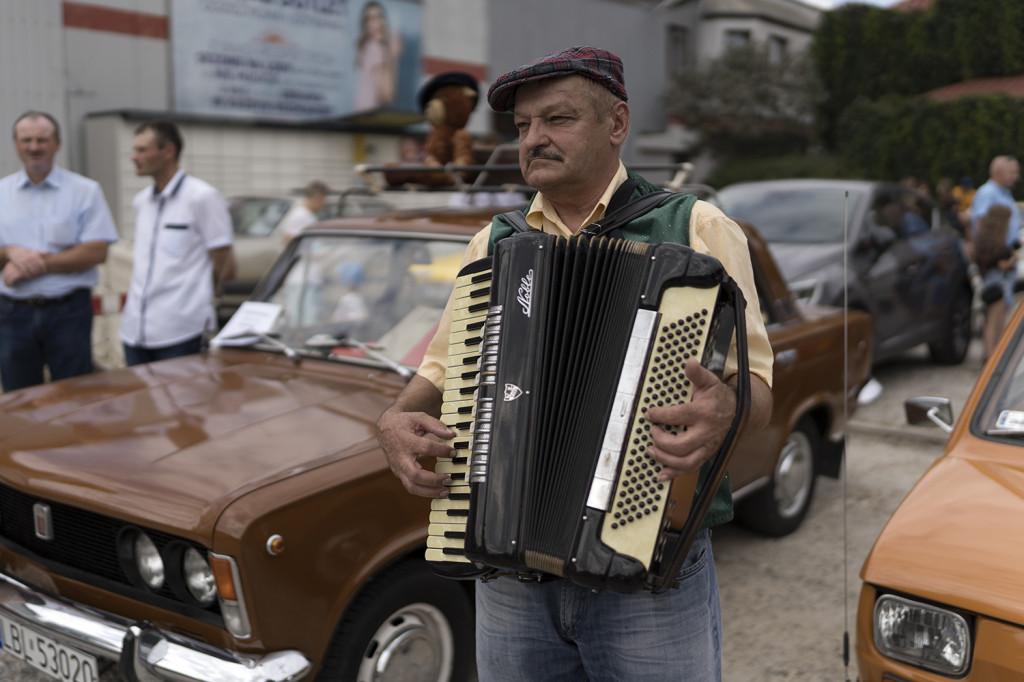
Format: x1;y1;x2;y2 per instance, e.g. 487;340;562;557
718;183;865;244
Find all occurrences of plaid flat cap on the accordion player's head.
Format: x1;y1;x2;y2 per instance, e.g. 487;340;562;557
487;47;629;112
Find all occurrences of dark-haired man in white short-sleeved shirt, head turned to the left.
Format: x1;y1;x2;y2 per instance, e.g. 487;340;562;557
121;121;236;366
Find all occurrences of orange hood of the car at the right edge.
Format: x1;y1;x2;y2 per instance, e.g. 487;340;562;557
861;447;1024;625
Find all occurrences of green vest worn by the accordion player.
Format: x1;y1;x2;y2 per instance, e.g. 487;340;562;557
487;171;732;528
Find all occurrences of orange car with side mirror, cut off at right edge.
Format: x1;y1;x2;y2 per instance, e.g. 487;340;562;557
856;296;1024;682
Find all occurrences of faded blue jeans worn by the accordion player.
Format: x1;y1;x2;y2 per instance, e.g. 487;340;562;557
476;529;722;682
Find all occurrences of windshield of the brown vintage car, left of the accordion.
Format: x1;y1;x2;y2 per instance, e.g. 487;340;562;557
249;233;466;367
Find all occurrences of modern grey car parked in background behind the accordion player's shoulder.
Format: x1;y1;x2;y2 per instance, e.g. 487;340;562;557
718;179;973;365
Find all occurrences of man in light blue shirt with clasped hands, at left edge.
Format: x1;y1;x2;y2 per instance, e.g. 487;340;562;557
0;112;118;391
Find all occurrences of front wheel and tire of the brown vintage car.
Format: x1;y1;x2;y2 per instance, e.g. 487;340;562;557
316;561;476;682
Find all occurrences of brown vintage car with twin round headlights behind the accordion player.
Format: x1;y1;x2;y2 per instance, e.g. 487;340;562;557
0;204;870;682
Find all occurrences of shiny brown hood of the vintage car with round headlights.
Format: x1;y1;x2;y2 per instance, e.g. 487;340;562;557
0;350;398;539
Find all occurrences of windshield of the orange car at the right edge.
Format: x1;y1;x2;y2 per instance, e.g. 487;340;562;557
971;319;1024;437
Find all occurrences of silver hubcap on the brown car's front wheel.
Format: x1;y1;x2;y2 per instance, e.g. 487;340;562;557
358;603;455;682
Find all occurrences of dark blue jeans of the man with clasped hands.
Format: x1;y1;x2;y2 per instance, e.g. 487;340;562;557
0;289;92;391
